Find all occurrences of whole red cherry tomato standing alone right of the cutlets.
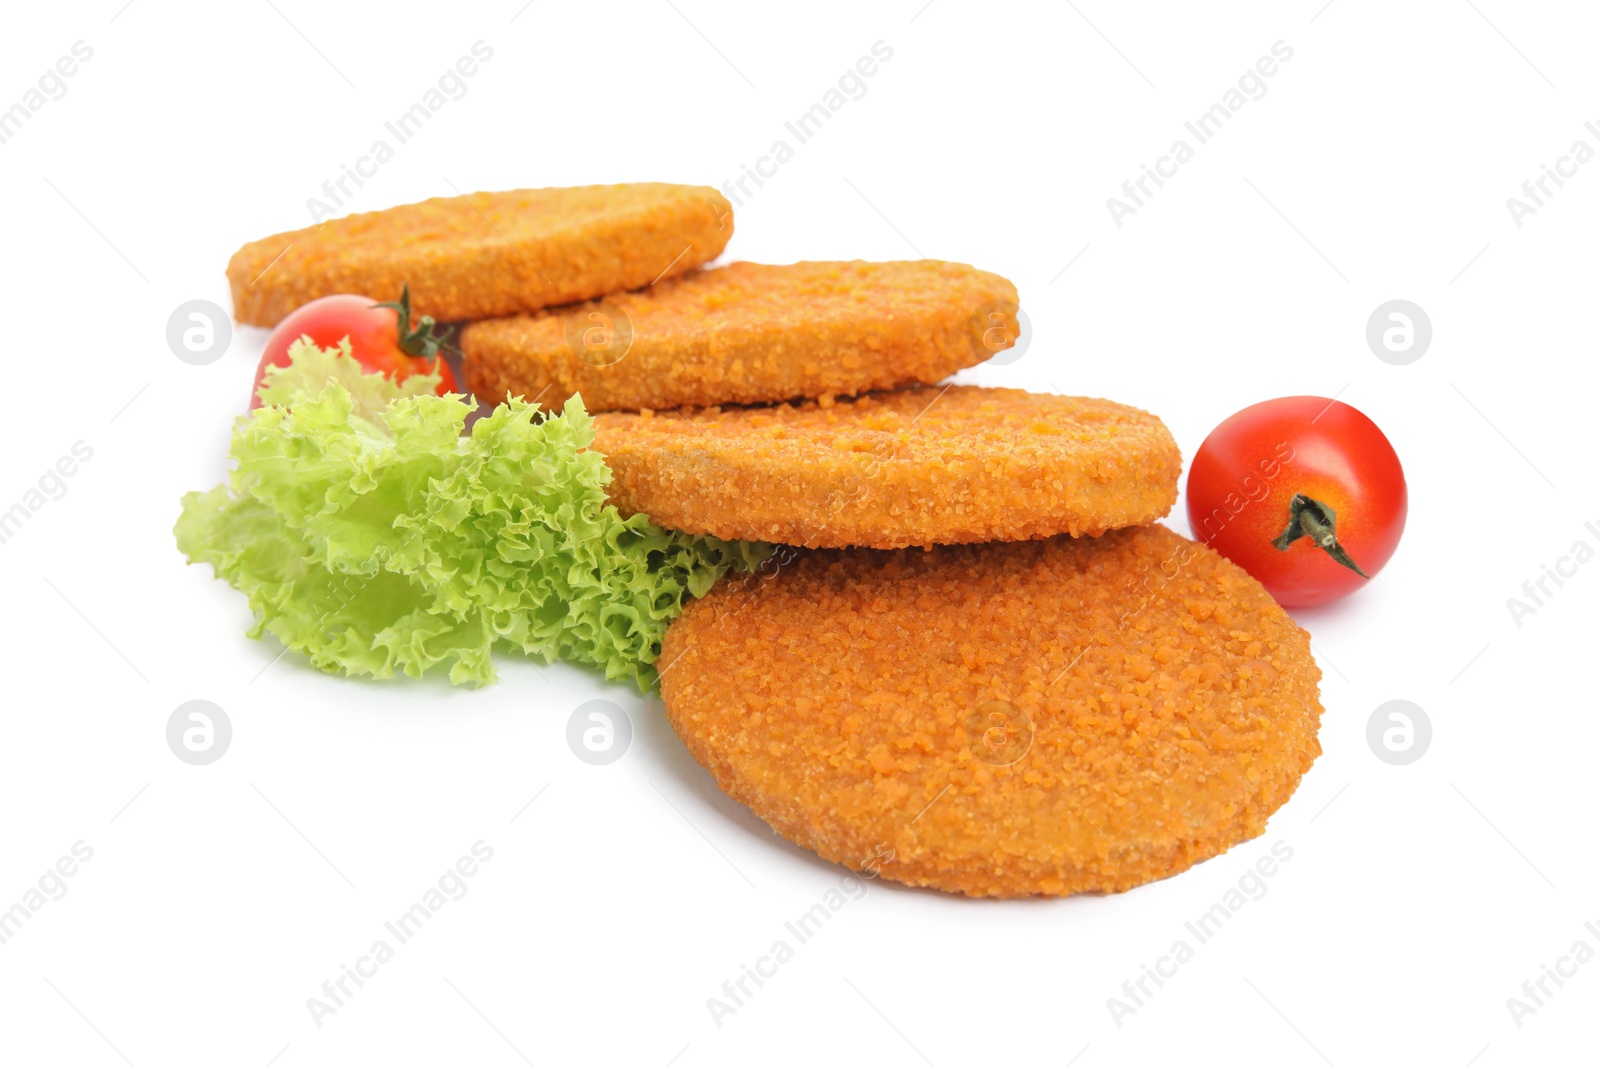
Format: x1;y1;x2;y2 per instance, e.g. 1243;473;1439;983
1186;397;1406;608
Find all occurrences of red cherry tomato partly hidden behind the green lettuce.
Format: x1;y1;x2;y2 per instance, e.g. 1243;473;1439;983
250;288;458;408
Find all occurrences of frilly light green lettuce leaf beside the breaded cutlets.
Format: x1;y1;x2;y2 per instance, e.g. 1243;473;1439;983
173;341;770;691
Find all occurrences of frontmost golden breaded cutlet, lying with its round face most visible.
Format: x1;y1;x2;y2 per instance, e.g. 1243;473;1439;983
659;526;1322;897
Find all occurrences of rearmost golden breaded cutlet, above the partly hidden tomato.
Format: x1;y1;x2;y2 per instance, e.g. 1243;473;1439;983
227;182;733;326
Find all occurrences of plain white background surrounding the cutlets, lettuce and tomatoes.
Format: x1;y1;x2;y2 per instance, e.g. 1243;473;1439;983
0;0;1600;1067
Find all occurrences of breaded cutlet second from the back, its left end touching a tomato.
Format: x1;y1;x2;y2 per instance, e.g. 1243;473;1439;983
461;259;1018;411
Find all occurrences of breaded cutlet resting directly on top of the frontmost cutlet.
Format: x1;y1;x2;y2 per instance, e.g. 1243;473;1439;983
594;386;1181;549
